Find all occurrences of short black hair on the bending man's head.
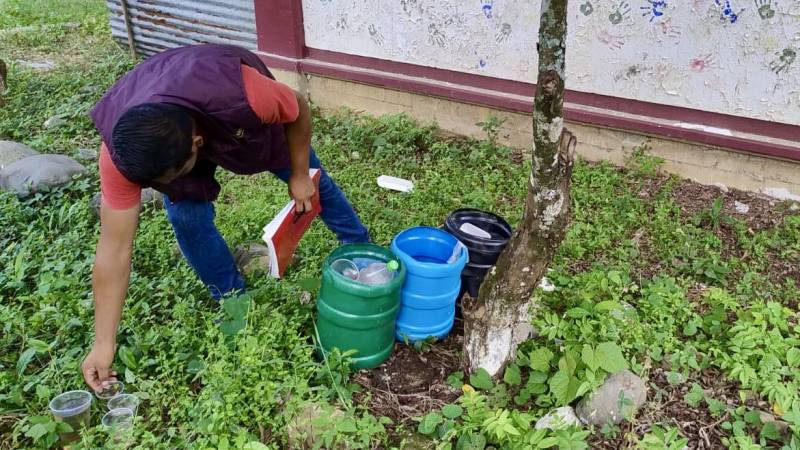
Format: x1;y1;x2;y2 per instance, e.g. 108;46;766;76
111;103;194;184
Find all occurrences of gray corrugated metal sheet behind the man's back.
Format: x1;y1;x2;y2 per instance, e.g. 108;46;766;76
106;0;258;56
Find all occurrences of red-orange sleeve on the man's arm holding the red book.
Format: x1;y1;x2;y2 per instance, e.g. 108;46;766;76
242;65;300;123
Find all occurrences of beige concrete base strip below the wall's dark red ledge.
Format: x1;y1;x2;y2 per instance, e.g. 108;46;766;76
273;70;800;199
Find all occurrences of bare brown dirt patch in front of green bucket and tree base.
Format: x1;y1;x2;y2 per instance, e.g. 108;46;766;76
353;320;463;427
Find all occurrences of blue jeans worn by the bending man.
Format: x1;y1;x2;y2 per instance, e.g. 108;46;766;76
164;149;370;299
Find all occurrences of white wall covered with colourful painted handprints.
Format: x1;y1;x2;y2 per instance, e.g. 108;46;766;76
303;0;800;125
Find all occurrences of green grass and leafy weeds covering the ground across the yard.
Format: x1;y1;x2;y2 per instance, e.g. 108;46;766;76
0;0;800;449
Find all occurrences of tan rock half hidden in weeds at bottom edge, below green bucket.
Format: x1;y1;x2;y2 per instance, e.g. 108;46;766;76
286;403;347;449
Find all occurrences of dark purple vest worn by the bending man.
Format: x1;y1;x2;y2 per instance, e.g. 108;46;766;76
90;44;289;201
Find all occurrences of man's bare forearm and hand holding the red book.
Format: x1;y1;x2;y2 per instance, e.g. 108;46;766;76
285;92;315;213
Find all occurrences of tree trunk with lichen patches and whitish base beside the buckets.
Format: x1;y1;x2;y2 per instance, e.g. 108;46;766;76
464;0;577;376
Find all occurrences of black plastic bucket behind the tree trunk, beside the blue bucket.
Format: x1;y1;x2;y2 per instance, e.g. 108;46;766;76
444;209;513;298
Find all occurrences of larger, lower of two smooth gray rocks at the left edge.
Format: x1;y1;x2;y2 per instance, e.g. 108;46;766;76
0;155;86;197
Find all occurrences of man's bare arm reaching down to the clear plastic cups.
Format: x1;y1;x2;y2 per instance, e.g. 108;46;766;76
81;205;139;390
